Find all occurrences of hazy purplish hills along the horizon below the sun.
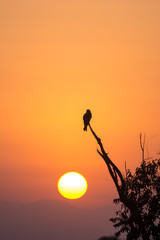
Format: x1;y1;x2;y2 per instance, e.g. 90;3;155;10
0;199;115;240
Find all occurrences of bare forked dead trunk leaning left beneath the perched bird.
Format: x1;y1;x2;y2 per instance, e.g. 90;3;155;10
89;124;149;240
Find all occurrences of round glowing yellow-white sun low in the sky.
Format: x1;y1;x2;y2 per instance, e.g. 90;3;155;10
58;172;88;199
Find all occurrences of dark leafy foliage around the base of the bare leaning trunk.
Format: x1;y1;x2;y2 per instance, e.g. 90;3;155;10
110;159;160;240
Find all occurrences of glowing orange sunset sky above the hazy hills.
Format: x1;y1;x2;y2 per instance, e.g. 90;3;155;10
0;0;160;206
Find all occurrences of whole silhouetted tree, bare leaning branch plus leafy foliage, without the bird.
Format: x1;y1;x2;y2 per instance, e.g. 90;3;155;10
84;111;160;240
